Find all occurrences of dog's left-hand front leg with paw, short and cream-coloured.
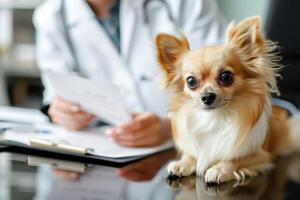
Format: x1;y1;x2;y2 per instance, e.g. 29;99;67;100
167;154;196;177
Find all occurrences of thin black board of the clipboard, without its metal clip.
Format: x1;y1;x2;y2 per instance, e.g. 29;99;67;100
0;141;152;168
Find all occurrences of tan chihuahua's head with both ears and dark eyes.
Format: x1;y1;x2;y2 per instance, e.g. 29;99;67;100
156;17;278;110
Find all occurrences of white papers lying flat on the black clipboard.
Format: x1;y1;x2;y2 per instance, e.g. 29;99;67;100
0;124;173;158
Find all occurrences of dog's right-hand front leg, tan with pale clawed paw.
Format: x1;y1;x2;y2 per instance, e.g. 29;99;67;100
205;150;273;184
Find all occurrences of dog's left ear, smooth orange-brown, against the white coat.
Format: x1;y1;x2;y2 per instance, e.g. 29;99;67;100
156;34;189;87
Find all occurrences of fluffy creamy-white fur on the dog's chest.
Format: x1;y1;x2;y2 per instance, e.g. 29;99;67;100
174;100;271;173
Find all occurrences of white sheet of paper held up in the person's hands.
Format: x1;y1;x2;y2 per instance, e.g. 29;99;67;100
46;70;131;125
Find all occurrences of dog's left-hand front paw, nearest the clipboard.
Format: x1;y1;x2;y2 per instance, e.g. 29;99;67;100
167;160;196;177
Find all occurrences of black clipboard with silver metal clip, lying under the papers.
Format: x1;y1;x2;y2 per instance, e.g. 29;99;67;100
0;130;172;167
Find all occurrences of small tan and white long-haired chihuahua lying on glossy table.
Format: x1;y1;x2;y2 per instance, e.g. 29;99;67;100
156;17;300;183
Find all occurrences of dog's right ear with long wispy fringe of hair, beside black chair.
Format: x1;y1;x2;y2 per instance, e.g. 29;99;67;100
227;16;281;94
